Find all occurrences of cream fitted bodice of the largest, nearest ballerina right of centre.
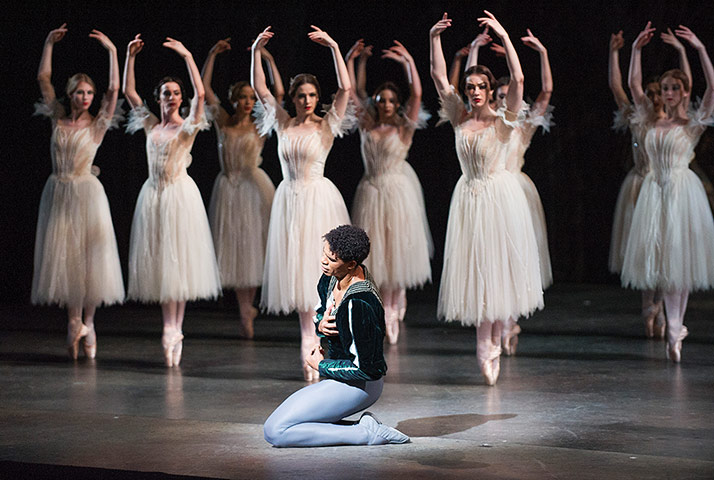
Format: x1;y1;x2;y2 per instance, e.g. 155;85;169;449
454;125;508;180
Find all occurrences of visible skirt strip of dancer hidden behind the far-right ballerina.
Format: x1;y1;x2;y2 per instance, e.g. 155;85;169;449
609;169;644;273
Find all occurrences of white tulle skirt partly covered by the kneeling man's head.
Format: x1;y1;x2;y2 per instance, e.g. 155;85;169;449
260;177;350;313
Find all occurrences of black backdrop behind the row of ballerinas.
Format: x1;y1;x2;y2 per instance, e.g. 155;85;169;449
0;0;714;304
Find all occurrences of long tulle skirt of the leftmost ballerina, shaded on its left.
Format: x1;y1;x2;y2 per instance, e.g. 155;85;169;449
32;174;124;308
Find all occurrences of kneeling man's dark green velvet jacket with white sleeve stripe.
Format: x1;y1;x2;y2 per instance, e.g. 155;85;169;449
315;265;387;382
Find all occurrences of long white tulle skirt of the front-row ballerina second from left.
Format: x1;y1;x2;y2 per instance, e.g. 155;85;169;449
128;175;221;303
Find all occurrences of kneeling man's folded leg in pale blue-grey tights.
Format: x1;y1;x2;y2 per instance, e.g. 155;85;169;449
263;379;386;447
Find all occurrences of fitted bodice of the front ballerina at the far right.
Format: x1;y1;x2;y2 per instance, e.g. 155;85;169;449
644;125;699;184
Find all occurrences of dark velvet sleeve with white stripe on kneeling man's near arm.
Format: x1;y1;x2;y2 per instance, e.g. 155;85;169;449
320;299;387;382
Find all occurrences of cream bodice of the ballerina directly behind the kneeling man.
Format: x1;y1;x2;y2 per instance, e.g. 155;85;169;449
278;128;334;180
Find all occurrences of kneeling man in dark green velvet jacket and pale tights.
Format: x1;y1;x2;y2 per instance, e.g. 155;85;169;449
263;225;409;447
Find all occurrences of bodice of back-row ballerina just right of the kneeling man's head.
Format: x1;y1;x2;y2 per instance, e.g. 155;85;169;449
360;129;411;177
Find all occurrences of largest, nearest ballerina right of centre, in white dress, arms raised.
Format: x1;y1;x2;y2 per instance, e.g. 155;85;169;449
430;11;543;385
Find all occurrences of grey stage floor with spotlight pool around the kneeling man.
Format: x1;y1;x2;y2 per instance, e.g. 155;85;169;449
0;285;714;480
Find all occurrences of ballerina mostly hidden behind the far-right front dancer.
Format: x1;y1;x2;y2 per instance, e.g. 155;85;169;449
608;29;692;338
